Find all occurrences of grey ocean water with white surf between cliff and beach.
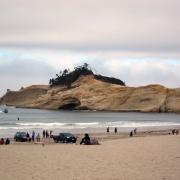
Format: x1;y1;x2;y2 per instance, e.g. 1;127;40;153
0;107;180;137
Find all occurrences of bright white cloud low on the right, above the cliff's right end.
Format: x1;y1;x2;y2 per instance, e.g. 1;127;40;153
99;58;180;88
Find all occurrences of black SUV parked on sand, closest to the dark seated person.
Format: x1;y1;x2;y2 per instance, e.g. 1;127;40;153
53;133;77;143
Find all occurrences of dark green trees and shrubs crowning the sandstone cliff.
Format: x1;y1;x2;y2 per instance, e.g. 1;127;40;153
49;63;125;88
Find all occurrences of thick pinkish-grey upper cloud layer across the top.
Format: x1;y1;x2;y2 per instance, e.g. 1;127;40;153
0;0;180;54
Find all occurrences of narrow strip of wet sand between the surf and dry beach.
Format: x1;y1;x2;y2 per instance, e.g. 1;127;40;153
0;125;180;140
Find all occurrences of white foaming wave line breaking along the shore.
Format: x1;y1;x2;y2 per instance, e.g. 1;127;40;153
0;121;180;130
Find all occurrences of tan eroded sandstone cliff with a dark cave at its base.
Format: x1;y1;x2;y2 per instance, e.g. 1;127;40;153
0;76;180;112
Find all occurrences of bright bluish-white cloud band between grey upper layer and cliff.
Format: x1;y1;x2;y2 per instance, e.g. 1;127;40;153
0;49;180;95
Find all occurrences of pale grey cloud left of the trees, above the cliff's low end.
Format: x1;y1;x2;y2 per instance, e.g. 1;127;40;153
0;57;56;96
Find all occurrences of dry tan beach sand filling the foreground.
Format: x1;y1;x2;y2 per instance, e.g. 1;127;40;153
0;133;180;180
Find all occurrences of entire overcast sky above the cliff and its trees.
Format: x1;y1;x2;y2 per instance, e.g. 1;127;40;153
0;0;180;96
